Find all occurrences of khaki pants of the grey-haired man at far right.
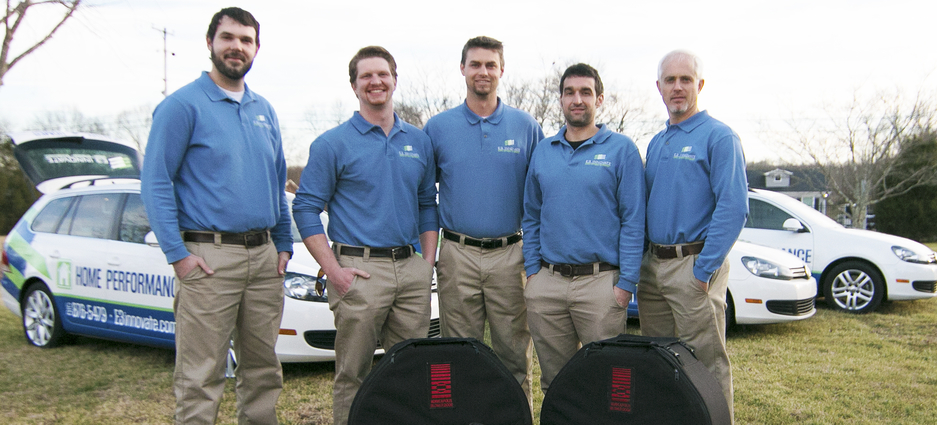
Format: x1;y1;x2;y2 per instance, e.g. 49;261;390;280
637;252;733;422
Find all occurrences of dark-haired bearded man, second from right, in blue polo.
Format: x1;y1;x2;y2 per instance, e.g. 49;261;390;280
523;63;645;393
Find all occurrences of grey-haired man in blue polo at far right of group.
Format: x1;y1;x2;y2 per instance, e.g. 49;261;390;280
638;50;748;420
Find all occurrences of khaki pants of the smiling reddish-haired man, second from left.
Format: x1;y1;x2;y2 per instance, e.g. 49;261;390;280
328;243;433;425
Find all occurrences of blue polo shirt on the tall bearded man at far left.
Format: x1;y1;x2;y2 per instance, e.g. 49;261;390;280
140;72;293;263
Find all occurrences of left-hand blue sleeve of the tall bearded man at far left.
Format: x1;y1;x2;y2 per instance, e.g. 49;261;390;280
140;98;194;263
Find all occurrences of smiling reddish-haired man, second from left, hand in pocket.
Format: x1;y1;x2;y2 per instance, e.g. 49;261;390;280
293;46;439;425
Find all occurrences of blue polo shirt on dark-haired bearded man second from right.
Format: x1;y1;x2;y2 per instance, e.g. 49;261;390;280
523;124;645;293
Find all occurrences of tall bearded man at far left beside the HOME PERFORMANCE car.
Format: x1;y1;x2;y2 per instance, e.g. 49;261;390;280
141;8;292;424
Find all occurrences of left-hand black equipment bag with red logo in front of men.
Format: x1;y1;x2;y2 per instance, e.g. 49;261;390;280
348;338;532;425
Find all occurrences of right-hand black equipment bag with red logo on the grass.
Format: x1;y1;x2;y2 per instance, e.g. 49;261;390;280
540;334;731;425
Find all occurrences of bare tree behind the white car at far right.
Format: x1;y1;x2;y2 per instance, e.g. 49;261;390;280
780;91;937;228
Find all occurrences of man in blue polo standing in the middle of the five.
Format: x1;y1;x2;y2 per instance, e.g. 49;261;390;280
423;36;543;403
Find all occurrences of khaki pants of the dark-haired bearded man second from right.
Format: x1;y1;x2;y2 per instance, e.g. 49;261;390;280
524;268;628;394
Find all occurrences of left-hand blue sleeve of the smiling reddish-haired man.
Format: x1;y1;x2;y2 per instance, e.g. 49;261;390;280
293;135;338;239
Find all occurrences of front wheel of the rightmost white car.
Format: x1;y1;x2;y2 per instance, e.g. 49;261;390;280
823;261;885;314
